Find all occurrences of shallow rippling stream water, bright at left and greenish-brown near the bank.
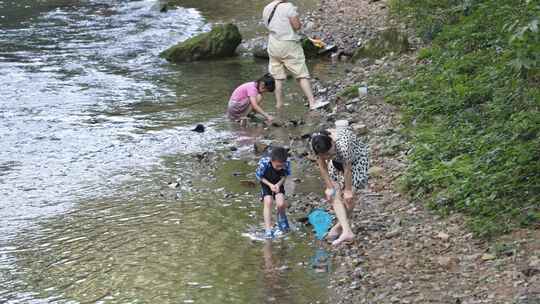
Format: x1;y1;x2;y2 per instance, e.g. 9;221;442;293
0;0;346;303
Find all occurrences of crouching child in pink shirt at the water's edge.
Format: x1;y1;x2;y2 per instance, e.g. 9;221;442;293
227;74;275;124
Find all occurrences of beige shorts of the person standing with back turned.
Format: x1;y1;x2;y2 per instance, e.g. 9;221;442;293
268;37;309;80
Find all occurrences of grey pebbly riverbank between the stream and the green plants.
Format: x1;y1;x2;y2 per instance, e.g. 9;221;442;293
296;0;540;303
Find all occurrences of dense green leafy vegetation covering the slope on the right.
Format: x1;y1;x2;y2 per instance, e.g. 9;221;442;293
387;0;540;237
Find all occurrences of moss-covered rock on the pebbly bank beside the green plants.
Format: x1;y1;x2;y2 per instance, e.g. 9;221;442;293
353;28;410;60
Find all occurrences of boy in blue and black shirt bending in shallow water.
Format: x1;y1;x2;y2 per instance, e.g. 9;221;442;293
256;147;291;239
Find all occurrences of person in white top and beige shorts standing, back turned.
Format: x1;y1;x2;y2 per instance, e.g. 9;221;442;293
263;0;328;110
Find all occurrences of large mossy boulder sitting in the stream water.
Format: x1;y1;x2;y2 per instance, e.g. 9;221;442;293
160;23;242;62
